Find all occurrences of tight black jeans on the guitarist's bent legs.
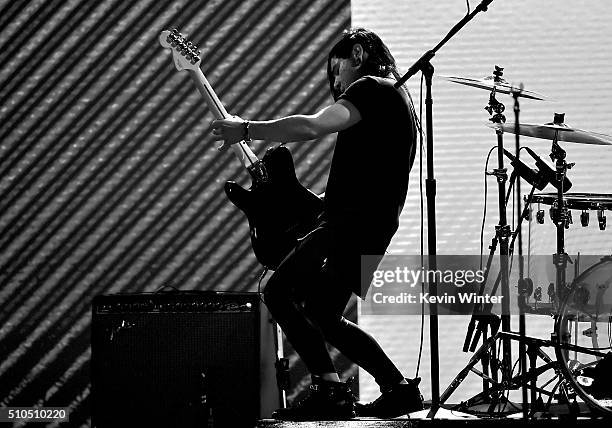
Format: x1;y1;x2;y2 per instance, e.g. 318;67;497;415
264;225;403;390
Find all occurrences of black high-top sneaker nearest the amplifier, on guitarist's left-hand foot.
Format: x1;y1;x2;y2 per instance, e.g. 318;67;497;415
272;376;355;421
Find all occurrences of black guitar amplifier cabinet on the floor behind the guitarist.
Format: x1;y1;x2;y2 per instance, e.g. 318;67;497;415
91;291;279;428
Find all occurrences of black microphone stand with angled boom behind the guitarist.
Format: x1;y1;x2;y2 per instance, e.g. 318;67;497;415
395;0;493;419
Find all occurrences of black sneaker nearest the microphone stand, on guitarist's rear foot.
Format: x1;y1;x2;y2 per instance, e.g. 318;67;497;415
355;377;423;418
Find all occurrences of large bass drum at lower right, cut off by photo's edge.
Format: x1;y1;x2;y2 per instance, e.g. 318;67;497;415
553;256;612;416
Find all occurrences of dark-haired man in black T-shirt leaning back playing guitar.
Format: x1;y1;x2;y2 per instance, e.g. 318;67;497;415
212;29;423;420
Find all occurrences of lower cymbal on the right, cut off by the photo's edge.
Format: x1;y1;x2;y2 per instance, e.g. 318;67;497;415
487;122;612;146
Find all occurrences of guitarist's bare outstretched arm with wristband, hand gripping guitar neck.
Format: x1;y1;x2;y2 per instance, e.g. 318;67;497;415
212;100;361;150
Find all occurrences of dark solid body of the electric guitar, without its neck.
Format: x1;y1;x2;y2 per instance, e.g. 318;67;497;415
225;146;323;270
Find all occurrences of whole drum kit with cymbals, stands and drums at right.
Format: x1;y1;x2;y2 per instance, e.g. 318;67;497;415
441;66;612;416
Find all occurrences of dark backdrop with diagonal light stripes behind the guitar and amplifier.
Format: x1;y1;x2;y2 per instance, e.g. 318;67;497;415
0;0;355;426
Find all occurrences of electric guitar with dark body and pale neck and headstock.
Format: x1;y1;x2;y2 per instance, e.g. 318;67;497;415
159;29;323;269
